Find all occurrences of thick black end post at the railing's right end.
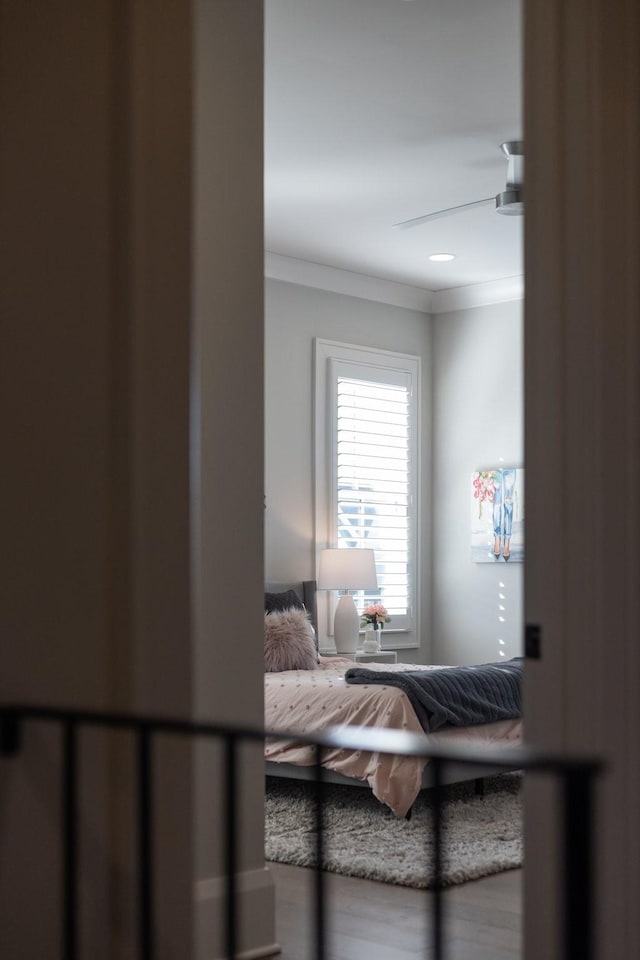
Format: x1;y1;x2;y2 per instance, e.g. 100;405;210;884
563;769;594;960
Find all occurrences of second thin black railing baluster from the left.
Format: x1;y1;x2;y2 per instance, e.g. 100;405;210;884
138;725;154;960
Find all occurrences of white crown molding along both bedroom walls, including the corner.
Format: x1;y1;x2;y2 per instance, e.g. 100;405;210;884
264;251;524;314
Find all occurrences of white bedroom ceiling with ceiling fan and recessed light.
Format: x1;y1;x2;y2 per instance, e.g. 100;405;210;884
265;0;523;291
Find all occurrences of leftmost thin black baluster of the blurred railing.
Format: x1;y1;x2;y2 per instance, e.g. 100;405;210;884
62;719;78;960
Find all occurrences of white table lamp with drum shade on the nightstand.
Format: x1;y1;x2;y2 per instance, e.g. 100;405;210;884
318;547;378;653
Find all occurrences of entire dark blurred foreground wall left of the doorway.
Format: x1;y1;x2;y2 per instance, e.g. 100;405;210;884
0;0;276;960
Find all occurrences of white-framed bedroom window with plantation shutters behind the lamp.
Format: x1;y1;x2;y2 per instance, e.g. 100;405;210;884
316;340;420;647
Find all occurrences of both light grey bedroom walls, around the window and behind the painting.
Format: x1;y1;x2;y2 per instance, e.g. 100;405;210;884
265;280;524;663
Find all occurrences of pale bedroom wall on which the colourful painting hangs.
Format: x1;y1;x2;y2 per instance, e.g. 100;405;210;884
432;301;526;663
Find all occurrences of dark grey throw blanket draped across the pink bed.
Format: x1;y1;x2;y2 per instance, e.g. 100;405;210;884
344;657;522;733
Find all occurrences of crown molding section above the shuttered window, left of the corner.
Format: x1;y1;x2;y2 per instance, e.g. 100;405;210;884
265;251;433;313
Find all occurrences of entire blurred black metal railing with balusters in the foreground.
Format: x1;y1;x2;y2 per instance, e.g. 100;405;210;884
0;703;602;960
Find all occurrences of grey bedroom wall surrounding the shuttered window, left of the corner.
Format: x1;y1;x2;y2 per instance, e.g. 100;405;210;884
265;279;431;662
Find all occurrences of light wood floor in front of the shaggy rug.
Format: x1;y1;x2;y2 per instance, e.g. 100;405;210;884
269;863;522;960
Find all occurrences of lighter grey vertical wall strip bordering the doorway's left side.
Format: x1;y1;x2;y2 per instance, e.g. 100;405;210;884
194;0;275;960
